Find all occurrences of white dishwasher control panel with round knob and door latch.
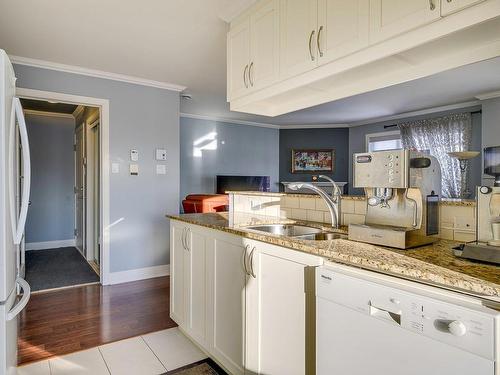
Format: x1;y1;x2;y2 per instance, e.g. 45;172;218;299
316;267;500;360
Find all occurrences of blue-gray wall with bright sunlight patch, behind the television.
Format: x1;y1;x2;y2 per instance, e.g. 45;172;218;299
180;117;279;199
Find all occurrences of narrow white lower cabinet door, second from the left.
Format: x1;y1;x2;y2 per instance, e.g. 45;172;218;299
183;227;208;347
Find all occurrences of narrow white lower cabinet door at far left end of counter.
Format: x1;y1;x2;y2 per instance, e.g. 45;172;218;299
170;220;186;326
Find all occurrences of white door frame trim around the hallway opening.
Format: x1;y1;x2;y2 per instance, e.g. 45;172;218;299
16;87;111;285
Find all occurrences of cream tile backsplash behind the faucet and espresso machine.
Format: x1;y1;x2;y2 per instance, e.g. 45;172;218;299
229;192;476;242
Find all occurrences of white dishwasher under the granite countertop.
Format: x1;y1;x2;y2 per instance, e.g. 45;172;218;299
316;265;500;375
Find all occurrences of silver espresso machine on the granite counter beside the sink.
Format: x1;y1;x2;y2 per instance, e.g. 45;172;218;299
349;150;441;249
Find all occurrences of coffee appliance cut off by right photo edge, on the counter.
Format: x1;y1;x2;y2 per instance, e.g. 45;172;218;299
455;146;500;264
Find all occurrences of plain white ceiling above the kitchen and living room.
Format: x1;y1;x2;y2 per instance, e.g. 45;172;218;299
0;0;500;125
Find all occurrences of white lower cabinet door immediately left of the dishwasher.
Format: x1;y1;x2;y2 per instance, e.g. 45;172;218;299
245;243;320;375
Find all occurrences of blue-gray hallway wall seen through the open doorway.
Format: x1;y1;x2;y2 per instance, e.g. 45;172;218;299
26;115;75;243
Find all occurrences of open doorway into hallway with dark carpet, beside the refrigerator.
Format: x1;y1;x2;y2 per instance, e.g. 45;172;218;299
21;99;100;291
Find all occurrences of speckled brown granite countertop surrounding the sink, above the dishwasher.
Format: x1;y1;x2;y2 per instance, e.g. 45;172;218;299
167;212;500;302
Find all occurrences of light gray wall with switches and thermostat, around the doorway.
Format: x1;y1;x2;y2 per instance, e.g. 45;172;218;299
14;65;180;272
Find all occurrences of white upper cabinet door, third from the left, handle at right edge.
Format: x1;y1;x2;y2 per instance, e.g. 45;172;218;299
279;0;318;78
